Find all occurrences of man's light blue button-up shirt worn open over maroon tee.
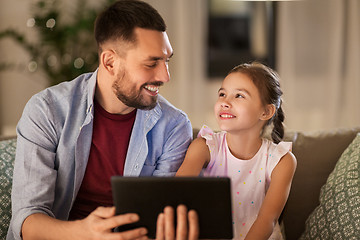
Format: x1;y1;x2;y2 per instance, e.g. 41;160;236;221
7;71;192;239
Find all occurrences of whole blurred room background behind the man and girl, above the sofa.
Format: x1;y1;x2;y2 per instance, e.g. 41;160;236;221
0;0;360;136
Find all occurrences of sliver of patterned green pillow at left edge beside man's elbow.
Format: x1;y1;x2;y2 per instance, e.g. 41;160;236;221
0;138;16;239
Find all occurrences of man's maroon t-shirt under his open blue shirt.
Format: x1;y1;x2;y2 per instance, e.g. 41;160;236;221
69;101;136;220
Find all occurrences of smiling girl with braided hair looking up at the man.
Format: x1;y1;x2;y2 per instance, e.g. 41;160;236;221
176;63;296;239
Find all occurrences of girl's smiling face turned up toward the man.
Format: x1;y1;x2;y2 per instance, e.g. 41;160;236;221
214;72;265;132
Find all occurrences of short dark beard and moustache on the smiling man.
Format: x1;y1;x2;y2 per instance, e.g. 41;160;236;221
112;70;162;110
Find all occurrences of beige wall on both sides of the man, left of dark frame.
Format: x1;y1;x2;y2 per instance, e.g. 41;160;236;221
0;0;219;135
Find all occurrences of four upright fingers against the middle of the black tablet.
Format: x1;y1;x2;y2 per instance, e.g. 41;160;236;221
156;205;199;240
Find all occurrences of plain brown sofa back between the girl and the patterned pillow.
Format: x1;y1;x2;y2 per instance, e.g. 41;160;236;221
282;128;360;240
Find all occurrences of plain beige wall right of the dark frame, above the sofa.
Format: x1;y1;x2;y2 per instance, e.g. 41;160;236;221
277;0;360;130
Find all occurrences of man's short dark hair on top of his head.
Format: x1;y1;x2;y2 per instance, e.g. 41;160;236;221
94;0;166;48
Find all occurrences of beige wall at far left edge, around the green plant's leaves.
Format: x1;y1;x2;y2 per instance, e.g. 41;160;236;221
0;0;46;135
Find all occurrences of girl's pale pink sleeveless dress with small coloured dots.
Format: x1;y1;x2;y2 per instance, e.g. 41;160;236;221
198;126;292;240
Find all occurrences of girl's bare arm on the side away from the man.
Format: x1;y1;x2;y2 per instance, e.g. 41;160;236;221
245;152;296;240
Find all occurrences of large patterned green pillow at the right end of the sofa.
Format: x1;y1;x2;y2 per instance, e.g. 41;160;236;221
300;133;360;240
